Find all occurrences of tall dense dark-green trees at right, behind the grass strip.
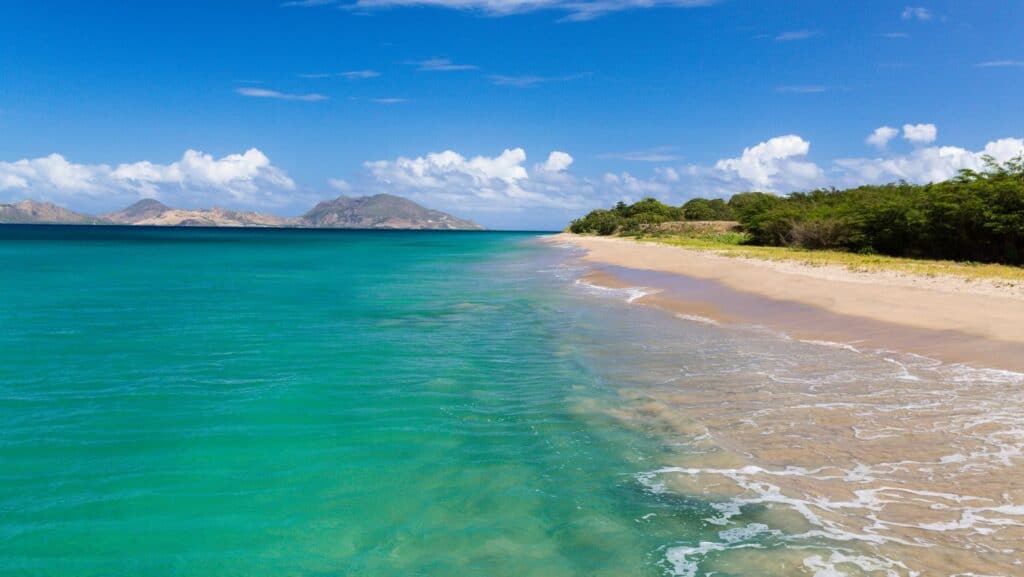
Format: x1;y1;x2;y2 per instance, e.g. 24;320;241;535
729;158;1024;264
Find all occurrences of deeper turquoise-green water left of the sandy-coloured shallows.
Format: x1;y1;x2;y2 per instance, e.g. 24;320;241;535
0;228;679;576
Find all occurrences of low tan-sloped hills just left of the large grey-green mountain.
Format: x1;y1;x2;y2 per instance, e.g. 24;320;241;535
103;199;291;226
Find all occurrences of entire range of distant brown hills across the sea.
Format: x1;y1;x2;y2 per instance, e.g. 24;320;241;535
0;195;483;231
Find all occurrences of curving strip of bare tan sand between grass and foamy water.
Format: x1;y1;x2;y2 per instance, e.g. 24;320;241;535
548;233;1024;371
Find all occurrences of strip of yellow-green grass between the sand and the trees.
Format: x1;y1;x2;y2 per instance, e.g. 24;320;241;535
618;231;1024;286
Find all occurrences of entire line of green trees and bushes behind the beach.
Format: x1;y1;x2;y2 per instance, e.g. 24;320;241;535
569;157;1024;265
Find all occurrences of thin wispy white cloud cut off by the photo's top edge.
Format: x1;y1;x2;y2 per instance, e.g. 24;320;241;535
283;0;720;22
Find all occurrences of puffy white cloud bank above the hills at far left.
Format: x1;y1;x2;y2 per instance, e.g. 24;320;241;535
0;149;295;210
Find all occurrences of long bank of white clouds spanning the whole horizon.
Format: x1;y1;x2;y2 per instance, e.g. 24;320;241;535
0;123;1024;225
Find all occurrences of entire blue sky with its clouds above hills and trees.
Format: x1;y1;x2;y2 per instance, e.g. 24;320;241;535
0;0;1024;230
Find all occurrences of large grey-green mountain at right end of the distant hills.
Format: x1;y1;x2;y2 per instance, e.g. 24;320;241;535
297;195;483;231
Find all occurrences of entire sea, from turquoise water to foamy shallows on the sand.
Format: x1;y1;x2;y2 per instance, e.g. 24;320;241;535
0;225;1024;577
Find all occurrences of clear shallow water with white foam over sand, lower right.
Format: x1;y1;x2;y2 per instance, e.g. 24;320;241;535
552;251;1024;577
